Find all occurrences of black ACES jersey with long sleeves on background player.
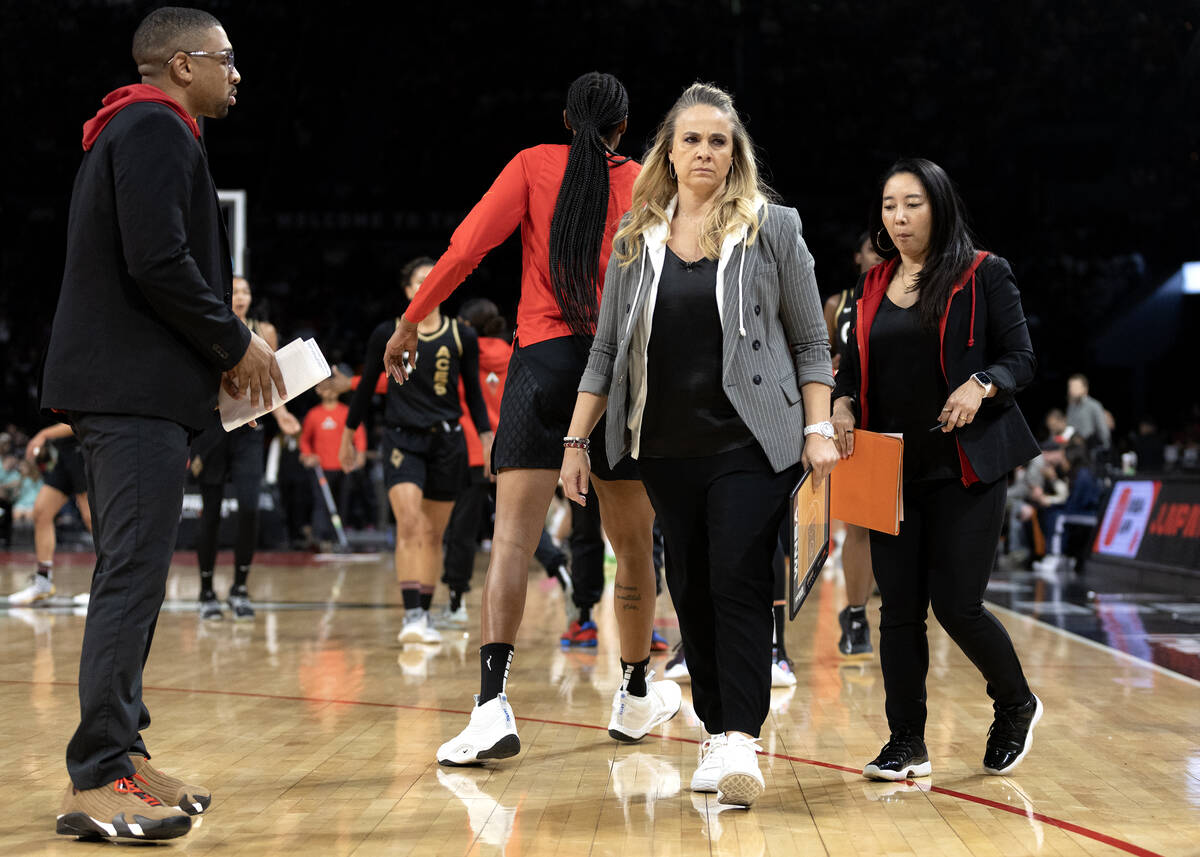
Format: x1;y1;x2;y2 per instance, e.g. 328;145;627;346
346;318;491;432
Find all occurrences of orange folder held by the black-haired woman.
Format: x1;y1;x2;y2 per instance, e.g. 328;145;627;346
829;429;904;535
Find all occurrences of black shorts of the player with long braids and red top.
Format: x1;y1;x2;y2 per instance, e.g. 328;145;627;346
492;336;641;480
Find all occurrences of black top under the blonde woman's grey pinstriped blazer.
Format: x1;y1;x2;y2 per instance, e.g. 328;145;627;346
640;247;754;459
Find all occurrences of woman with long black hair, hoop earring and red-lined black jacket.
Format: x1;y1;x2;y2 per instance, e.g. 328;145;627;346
833;158;1042;780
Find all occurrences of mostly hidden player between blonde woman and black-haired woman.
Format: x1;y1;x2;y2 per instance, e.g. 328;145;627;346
824;232;883;657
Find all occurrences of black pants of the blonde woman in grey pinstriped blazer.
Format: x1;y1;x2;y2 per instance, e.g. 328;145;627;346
638;444;799;736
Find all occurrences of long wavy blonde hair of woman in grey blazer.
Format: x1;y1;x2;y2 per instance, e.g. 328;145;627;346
613;83;774;265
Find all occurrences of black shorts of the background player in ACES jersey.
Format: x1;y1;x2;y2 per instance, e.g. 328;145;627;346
383;422;469;502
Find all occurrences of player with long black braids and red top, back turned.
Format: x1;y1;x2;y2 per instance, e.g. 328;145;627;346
384;72;679;765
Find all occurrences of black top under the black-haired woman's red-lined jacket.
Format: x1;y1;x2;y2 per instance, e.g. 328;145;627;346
866;295;962;483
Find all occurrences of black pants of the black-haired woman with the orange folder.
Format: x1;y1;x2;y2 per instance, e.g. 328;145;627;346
873;479;1030;736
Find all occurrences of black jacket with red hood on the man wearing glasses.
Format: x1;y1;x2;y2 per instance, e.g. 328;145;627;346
41;84;250;429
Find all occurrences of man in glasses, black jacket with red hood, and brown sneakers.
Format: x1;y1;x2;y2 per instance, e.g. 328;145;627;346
42;7;286;839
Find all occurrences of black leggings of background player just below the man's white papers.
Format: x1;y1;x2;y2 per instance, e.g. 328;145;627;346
192;426;265;571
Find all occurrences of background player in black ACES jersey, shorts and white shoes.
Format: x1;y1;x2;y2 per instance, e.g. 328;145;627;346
340;257;492;643
